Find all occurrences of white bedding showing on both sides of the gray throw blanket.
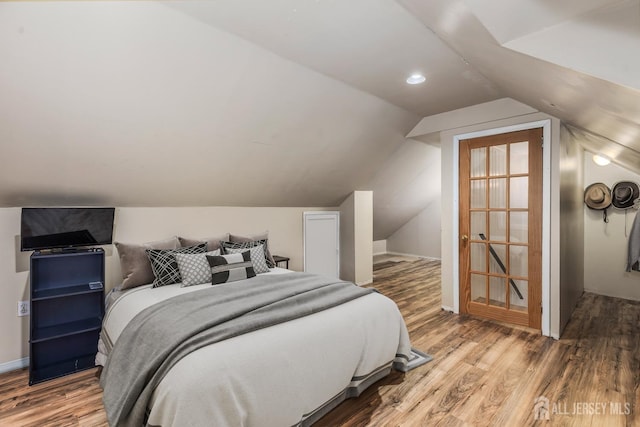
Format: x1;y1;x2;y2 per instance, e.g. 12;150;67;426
96;268;410;426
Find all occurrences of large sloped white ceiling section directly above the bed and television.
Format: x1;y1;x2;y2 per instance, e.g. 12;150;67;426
0;1;420;206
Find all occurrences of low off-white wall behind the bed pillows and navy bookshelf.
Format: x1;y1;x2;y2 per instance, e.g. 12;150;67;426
0;207;338;371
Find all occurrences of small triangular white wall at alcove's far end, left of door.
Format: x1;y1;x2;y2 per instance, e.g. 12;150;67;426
387;198;441;258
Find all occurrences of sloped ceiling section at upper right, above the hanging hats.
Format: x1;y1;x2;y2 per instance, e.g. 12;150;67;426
399;0;640;172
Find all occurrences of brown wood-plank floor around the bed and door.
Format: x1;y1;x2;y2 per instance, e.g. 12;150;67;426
0;260;640;426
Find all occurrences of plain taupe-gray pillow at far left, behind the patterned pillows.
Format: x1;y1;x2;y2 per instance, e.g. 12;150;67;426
114;236;180;289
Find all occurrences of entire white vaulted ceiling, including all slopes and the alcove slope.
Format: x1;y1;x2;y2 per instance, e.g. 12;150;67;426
0;0;640;239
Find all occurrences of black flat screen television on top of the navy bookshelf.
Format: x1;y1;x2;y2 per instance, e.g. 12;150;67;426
20;208;115;251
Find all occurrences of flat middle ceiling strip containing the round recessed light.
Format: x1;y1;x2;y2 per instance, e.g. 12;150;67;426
167;0;500;117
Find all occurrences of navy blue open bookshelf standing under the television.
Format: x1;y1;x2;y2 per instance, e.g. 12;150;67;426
29;249;104;385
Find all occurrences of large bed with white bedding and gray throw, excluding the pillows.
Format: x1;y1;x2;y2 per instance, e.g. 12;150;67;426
96;242;411;426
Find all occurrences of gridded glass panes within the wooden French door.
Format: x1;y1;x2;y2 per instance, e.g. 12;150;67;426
469;141;529;311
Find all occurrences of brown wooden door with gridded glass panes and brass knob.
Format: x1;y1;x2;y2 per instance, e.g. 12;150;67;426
459;128;542;329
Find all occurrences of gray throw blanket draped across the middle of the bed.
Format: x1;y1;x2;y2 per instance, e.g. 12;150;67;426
100;273;373;427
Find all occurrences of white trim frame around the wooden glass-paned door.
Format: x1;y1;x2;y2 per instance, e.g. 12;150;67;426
452;119;551;336
